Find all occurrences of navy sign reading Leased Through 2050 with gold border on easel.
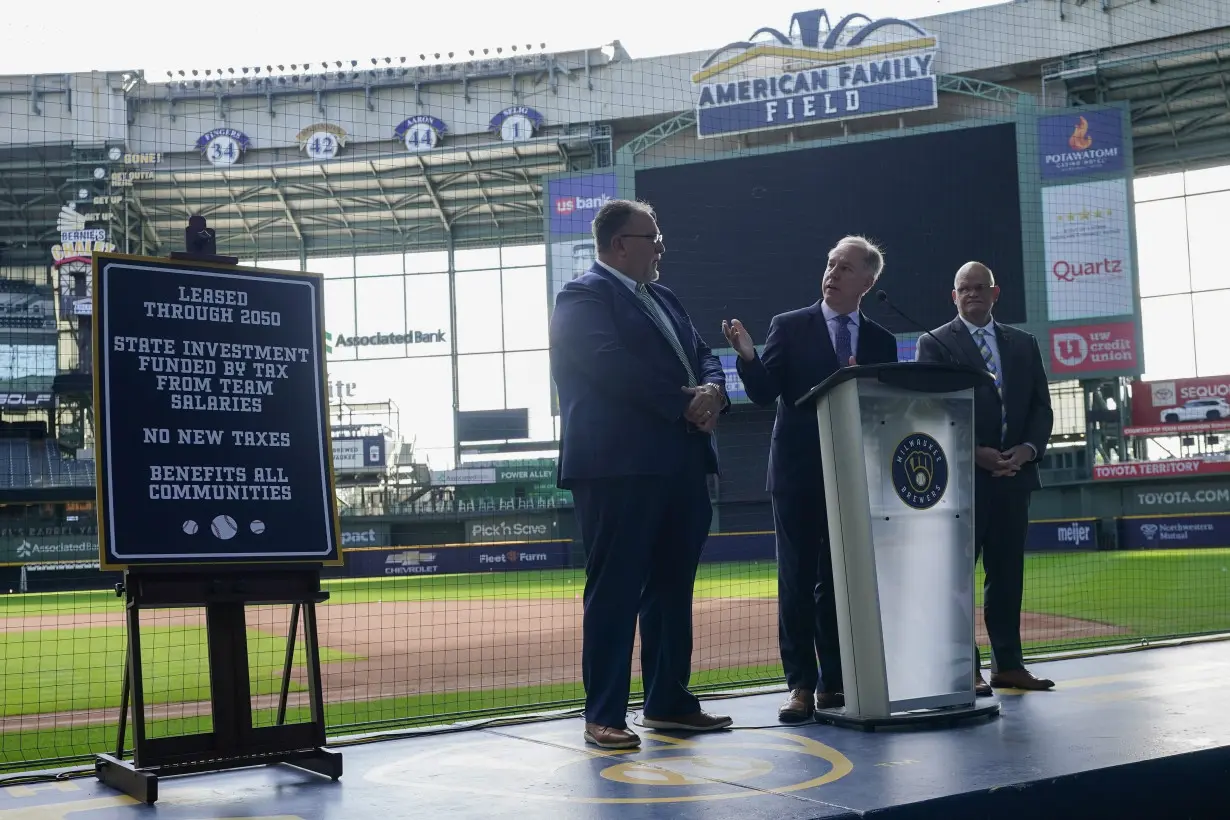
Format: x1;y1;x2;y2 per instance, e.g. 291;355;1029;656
93;253;339;567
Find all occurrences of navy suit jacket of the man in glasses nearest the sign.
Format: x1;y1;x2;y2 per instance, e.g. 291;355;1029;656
551;264;729;489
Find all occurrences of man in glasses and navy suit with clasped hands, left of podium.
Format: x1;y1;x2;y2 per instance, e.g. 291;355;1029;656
551;199;731;749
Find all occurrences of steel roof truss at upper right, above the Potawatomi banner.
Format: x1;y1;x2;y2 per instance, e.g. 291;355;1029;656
1042;39;1230;173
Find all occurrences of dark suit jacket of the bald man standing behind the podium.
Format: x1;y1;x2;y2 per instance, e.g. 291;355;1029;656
918;316;1054;492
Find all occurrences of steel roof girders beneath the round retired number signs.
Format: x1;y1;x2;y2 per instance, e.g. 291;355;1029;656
7;134;589;258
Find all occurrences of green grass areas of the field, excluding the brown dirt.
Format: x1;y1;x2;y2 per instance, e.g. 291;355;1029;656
0;550;1230;766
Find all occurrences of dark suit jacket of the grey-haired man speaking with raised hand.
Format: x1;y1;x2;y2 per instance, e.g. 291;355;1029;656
736;301;897;497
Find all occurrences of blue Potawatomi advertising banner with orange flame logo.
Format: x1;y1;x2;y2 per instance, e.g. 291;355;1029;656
1038;108;1124;182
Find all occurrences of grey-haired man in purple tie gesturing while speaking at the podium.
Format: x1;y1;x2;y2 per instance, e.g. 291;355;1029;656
722;236;897;723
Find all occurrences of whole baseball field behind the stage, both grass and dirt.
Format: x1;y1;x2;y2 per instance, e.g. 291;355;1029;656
0;550;1230;768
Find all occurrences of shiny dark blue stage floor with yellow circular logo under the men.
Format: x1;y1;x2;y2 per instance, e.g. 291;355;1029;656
0;643;1230;820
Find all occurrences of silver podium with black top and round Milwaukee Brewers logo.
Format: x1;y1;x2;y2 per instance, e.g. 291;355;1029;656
796;361;999;730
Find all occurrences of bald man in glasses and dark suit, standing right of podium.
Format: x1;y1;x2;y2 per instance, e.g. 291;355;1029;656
916;262;1054;696
